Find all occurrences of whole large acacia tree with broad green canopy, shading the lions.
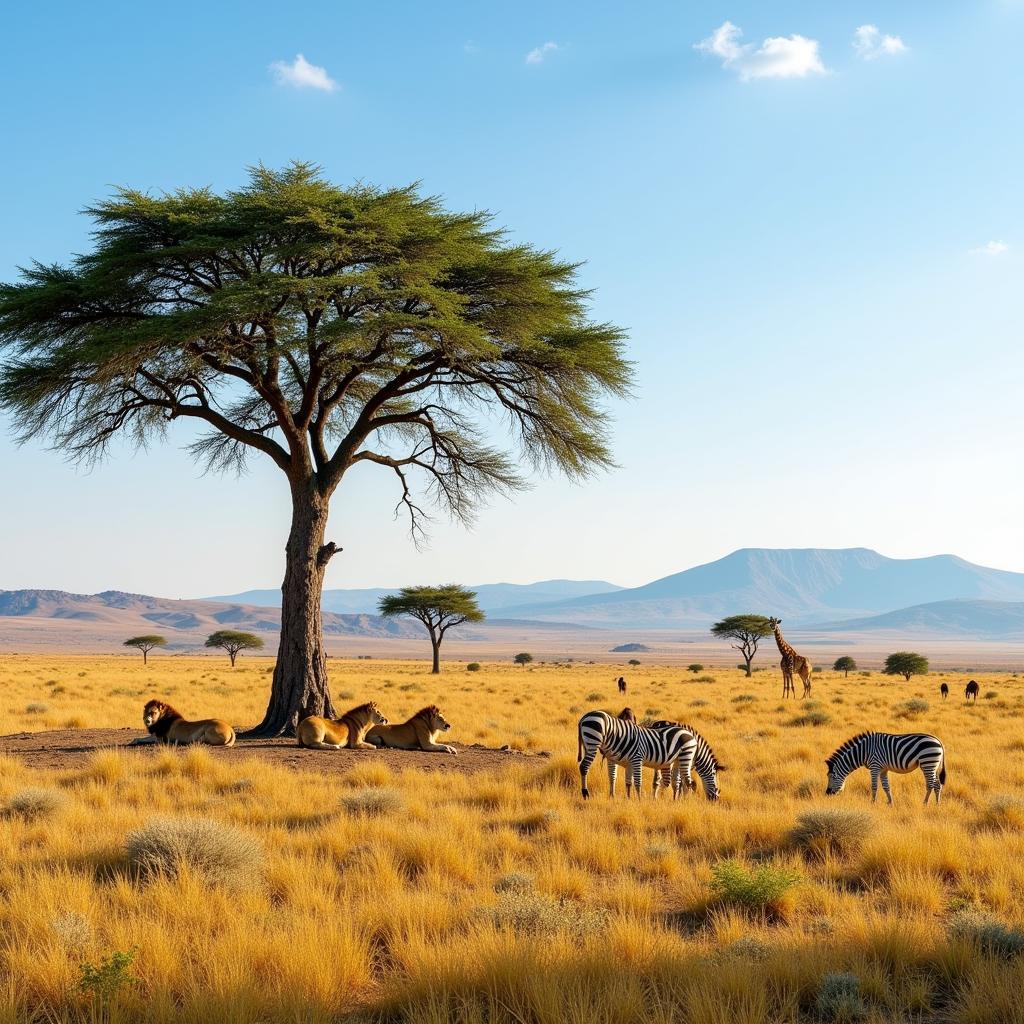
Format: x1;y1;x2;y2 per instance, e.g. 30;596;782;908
0;163;632;736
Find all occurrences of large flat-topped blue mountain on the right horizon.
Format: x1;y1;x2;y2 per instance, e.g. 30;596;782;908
493;548;1024;629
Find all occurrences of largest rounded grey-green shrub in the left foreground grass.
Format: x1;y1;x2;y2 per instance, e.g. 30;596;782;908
126;818;263;889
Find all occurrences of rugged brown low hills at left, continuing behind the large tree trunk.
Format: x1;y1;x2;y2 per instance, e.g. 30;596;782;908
0;590;421;647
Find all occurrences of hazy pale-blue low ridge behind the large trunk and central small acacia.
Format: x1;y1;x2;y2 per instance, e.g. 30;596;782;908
203;580;623;617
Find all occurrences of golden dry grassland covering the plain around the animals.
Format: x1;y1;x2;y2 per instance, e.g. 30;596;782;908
0;655;1024;1024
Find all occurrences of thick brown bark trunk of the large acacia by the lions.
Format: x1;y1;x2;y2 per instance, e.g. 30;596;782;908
244;478;337;737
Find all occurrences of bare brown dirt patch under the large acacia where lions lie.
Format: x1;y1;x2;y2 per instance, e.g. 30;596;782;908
0;729;543;775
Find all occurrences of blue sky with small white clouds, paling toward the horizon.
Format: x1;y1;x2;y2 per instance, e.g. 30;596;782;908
0;0;1024;598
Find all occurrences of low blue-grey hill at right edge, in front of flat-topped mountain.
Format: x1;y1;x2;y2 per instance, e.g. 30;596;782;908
819;600;1024;640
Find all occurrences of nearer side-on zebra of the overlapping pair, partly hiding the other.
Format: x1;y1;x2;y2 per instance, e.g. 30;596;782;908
577;711;696;800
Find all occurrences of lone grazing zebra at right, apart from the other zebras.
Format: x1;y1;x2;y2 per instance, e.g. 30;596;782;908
825;732;946;804
